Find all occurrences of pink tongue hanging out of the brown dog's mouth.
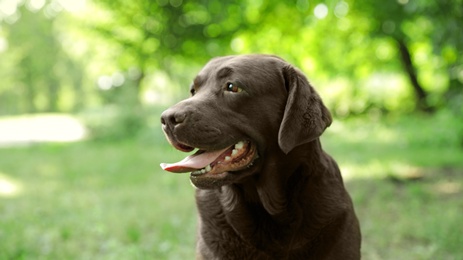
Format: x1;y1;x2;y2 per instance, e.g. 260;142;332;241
161;148;229;173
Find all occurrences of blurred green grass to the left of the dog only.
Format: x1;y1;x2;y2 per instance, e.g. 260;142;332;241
0;142;195;259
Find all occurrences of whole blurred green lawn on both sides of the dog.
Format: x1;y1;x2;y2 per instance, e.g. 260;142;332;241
0;110;463;260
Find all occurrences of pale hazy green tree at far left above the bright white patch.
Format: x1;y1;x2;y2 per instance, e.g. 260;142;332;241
0;3;81;113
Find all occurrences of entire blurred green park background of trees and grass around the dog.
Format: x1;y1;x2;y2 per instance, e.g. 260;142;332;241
0;0;463;259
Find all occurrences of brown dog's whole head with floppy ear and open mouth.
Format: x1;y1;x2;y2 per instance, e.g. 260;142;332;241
161;55;331;189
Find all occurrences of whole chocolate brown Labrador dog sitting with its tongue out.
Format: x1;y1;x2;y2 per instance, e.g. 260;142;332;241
161;55;361;260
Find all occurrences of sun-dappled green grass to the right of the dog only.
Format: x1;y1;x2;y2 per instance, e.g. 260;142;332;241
323;115;463;259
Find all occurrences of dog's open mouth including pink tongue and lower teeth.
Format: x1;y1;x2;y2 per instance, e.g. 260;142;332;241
161;141;258;177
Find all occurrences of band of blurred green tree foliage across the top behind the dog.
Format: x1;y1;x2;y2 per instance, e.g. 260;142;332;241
0;0;463;116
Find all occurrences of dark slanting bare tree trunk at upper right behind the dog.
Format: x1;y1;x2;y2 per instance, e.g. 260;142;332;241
395;38;433;112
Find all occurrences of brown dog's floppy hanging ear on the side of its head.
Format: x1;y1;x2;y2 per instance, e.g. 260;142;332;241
278;65;332;154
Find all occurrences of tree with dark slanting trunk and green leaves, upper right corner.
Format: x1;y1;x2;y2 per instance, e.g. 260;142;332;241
352;0;463;111
